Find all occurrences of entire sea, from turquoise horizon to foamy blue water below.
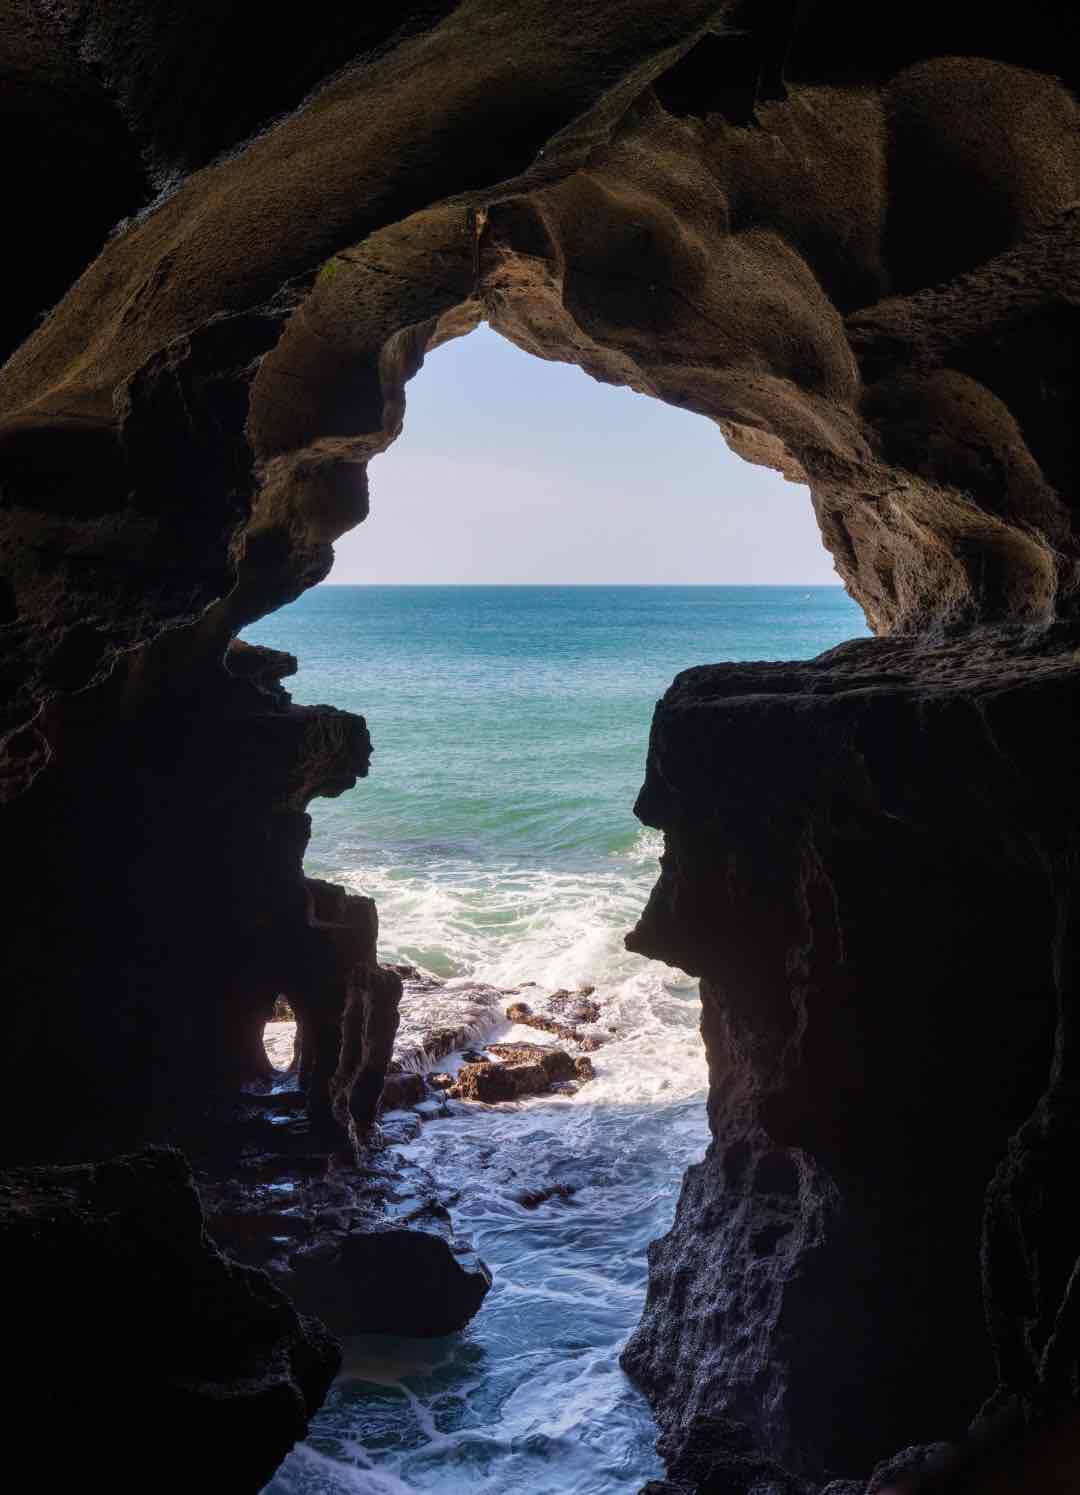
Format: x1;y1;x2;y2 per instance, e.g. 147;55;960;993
245;586;866;1495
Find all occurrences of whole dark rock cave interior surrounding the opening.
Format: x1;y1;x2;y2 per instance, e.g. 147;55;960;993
0;0;1080;1495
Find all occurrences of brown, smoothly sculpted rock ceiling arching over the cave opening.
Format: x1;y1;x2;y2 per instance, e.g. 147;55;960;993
0;0;1080;782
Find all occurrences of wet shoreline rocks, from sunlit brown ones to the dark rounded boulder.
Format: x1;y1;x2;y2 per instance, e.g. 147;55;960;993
196;966;610;1357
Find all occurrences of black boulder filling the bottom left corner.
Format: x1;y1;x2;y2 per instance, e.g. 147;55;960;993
0;1148;340;1495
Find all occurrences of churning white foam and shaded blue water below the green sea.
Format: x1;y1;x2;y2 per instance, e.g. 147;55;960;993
269;831;706;1495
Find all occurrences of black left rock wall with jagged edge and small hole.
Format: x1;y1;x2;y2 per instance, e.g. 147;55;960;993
0;634;401;1160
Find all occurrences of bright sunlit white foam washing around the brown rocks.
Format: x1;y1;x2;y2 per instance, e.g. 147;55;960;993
327;830;705;1105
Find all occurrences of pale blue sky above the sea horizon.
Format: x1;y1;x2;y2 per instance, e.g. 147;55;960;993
329;326;839;586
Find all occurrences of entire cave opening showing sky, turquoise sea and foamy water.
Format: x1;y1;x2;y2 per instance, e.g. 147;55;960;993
244;327;866;1495
